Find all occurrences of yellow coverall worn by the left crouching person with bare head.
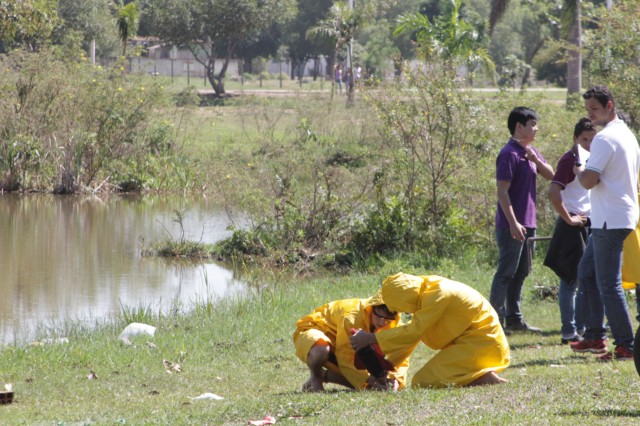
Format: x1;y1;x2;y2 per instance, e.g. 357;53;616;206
293;293;417;389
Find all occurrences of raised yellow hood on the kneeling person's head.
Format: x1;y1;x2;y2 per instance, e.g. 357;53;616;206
380;272;424;313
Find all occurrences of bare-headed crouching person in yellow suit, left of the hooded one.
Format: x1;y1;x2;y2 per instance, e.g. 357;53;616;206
293;292;416;392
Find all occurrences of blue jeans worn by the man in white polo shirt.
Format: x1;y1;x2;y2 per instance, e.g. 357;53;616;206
578;228;633;351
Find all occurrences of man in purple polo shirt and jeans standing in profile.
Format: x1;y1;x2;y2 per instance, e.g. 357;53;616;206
489;107;553;334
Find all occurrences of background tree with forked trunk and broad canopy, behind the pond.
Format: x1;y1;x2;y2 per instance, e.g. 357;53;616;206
146;0;295;96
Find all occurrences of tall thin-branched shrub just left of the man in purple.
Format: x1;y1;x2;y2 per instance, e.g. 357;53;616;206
354;62;487;257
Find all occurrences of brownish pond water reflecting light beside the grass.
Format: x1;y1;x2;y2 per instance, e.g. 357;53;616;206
0;194;246;343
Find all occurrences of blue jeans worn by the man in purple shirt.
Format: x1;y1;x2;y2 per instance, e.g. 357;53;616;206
489;228;536;325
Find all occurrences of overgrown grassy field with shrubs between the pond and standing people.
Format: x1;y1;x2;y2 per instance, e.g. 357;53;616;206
160;76;583;267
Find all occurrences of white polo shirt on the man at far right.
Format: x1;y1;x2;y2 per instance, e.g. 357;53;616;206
585;119;640;229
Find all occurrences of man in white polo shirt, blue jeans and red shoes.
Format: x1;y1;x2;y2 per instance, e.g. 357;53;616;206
571;86;640;361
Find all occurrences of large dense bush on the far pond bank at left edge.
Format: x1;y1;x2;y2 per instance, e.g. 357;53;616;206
0;50;185;194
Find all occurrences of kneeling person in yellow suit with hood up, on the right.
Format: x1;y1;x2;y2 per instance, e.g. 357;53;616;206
350;273;510;387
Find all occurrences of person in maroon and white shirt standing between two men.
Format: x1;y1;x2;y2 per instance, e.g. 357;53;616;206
544;118;596;344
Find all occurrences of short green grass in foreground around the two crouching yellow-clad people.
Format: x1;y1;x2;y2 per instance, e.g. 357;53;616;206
0;260;640;425
